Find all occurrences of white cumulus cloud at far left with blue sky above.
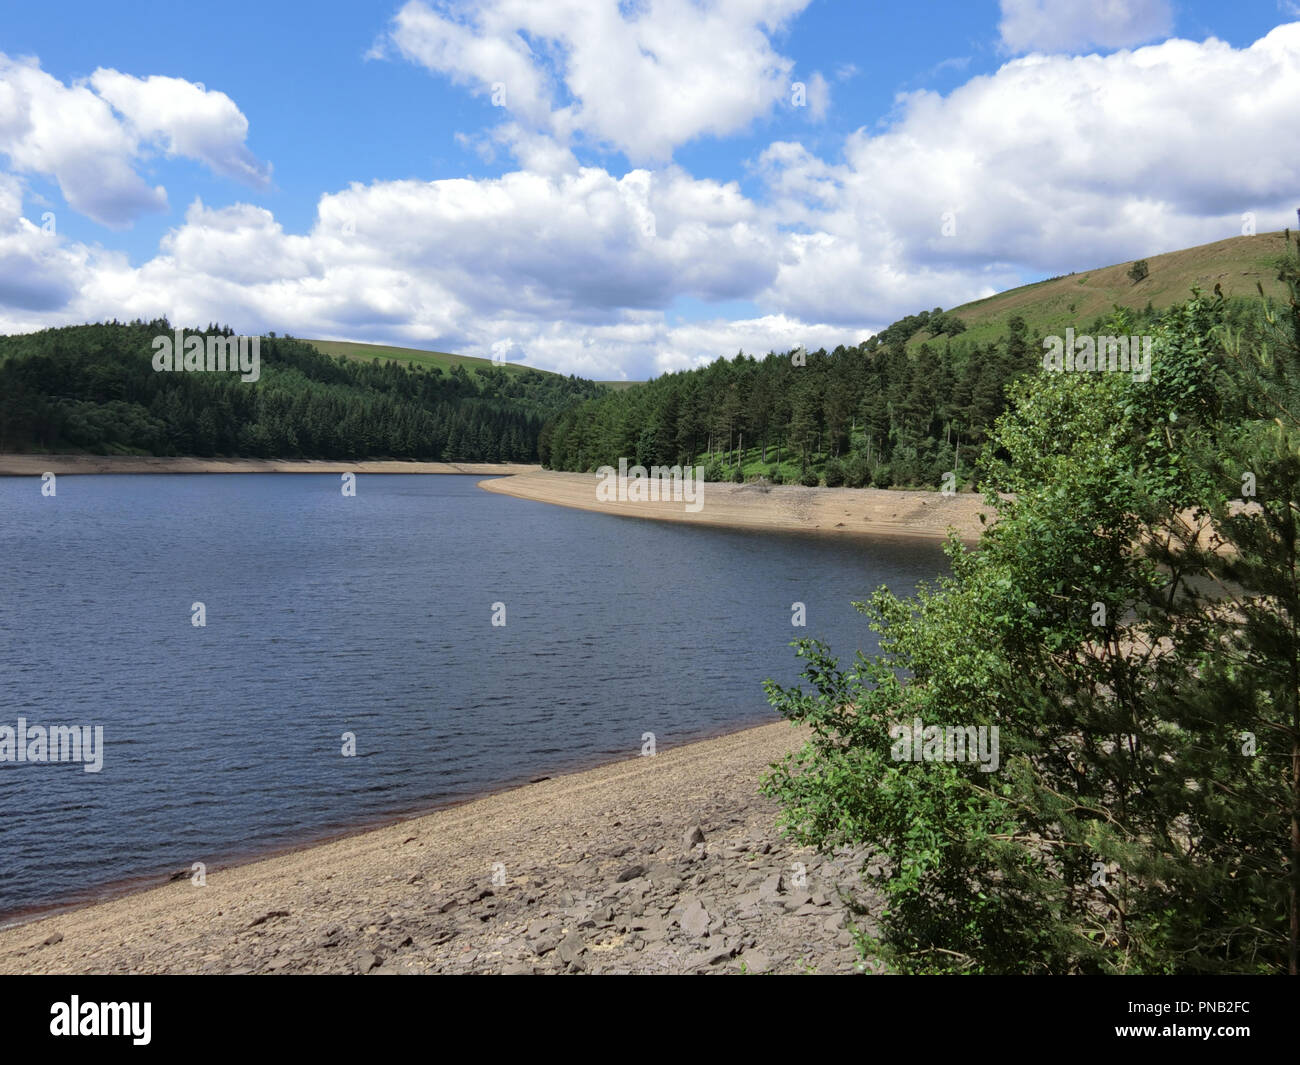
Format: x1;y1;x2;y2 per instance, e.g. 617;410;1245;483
0;53;269;229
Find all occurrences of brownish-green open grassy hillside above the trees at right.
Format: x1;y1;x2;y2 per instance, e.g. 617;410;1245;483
907;233;1286;350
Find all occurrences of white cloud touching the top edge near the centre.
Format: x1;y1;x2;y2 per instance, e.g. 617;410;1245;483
371;0;806;163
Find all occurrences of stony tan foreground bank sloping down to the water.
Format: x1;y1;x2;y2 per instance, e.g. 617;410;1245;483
0;722;870;974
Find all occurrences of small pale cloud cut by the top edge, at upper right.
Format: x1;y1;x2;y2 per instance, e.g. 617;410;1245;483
998;0;1174;52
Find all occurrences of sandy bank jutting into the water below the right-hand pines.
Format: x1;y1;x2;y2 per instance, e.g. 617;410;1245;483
478;469;997;544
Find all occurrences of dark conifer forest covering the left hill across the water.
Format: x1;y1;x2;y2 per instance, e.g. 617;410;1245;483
0;319;601;462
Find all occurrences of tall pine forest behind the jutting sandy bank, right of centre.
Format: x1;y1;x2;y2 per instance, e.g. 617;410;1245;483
541;297;1180;488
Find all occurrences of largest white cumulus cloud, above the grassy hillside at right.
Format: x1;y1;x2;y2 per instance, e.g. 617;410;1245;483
761;23;1300;320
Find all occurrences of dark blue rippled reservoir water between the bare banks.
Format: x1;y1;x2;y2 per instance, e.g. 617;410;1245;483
0;475;948;915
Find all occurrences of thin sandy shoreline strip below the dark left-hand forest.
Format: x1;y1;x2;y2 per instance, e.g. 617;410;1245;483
0;454;541;477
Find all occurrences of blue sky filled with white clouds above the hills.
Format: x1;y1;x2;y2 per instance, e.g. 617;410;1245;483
0;0;1300;380
